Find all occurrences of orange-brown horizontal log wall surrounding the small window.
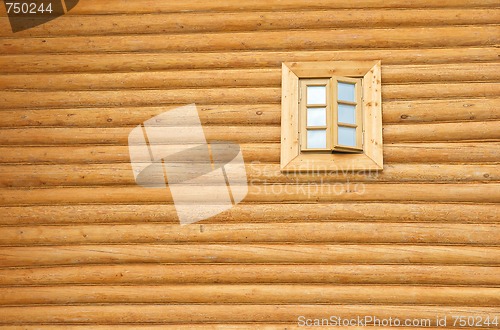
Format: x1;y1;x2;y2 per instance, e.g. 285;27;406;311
0;0;500;329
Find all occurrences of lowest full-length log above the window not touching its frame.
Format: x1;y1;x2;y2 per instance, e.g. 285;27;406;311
0;25;500;55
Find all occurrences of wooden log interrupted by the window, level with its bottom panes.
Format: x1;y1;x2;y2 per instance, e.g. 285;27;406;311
0;121;500;146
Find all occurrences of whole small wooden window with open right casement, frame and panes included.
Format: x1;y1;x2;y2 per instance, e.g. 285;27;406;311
281;61;383;172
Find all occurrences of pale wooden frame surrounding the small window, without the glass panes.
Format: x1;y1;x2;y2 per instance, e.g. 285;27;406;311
280;61;384;172
